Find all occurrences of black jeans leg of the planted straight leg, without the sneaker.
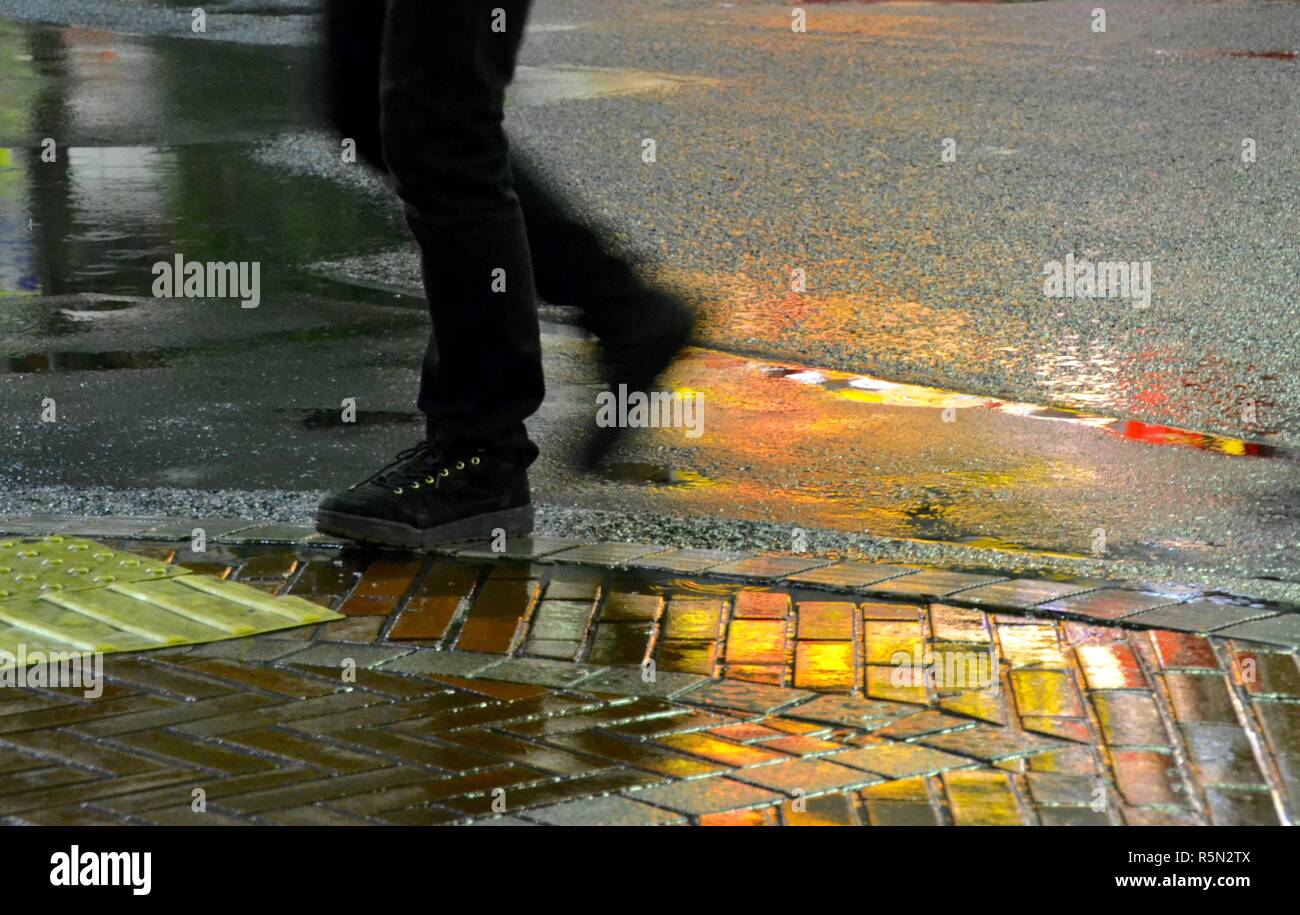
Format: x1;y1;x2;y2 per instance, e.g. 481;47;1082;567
380;0;543;461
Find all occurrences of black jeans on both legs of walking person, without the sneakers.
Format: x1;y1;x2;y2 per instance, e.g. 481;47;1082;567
326;0;641;461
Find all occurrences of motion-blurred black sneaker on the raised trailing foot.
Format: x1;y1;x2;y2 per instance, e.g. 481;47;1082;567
581;289;696;470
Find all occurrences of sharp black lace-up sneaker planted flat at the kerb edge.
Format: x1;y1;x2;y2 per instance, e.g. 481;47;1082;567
316;442;533;547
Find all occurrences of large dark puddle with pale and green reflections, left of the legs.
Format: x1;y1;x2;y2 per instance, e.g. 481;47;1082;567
0;22;408;310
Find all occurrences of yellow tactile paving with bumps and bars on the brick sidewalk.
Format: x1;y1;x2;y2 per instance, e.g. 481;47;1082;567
0;537;345;667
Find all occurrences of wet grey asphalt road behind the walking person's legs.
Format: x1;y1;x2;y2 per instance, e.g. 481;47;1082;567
0;0;1300;603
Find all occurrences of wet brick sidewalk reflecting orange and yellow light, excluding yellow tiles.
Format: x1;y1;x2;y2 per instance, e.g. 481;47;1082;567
0;529;1300;825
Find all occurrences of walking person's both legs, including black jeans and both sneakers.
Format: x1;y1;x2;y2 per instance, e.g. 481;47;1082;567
317;0;690;545
